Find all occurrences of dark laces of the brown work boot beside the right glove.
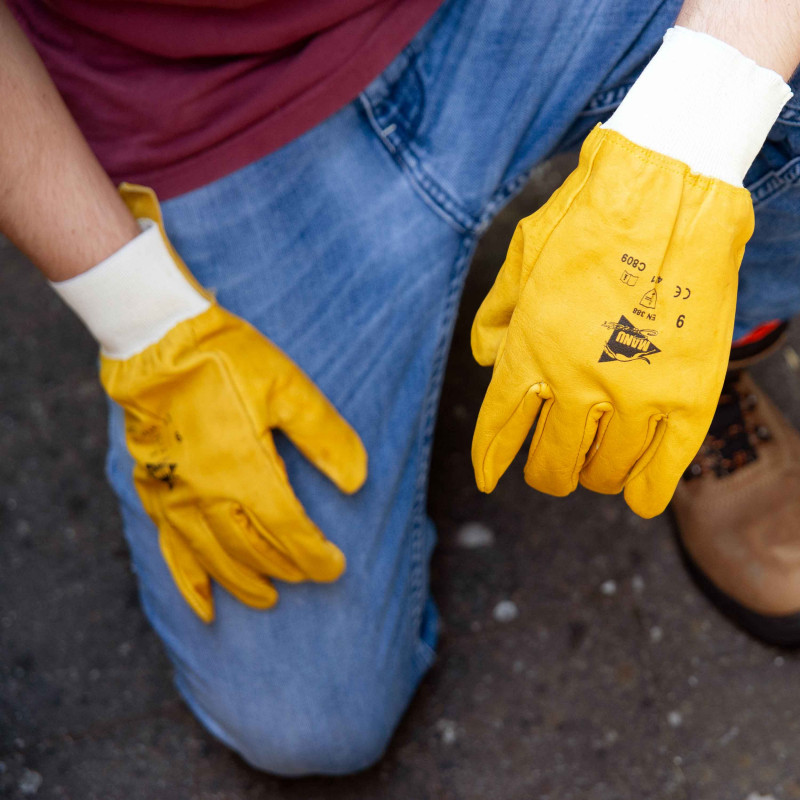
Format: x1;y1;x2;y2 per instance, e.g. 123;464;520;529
683;371;772;480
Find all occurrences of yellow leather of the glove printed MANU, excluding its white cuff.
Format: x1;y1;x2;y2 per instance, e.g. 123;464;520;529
472;126;753;517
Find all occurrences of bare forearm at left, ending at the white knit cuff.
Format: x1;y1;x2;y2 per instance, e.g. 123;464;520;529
0;0;139;281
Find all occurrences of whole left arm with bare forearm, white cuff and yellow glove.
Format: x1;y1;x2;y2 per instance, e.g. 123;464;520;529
0;5;367;622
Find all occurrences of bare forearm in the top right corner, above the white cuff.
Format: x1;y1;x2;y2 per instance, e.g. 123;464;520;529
675;0;800;81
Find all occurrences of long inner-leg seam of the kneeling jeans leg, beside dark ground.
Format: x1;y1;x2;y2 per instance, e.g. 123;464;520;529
410;236;476;667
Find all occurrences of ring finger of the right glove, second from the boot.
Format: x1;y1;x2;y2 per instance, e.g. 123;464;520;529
580;408;658;494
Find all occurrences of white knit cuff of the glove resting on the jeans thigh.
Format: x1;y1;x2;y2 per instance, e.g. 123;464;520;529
50;219;211;359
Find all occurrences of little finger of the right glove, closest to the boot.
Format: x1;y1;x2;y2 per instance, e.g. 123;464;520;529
625;414;696;519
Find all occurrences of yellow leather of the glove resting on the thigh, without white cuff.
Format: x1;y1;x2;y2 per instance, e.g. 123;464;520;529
54;184;367;622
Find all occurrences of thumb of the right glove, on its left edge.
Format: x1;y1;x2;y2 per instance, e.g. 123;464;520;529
470;222;525;367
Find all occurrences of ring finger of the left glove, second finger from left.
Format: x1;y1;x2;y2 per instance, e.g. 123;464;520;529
170;507;278;608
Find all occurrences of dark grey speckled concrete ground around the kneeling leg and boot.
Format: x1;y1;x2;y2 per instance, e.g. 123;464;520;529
0;164;800;800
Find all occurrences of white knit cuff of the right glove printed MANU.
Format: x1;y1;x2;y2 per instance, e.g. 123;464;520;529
603;27;792;186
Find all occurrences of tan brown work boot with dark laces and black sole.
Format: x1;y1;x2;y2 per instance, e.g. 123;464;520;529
672;348;800;646
